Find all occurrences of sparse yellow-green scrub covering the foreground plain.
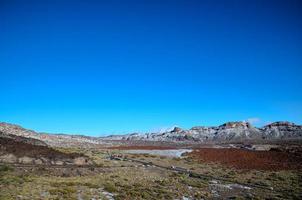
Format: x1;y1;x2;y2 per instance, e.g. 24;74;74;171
0;146;302;199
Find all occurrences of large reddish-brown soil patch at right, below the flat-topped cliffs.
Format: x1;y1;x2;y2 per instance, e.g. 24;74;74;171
188;148;302;170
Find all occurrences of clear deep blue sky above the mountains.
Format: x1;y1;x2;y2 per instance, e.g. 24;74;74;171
0;0;302;135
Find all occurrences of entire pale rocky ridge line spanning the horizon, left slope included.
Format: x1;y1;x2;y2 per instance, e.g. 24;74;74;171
0;122;302;147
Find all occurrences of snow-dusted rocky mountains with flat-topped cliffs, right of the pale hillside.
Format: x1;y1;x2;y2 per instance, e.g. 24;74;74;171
102;122;302;142
